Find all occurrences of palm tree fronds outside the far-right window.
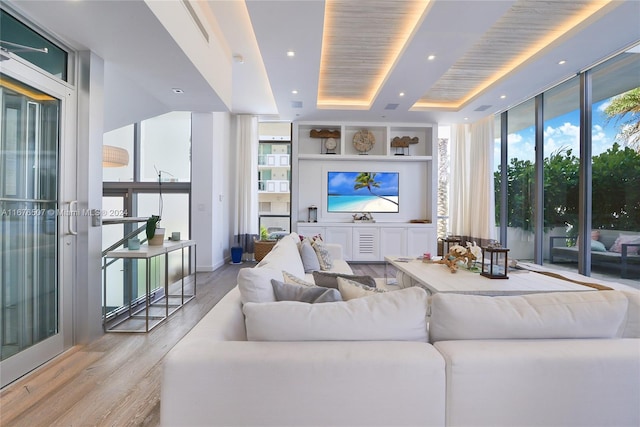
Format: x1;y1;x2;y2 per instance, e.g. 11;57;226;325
604;87;640;152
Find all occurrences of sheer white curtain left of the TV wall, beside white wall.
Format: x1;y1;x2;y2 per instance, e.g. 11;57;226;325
233;115;259;254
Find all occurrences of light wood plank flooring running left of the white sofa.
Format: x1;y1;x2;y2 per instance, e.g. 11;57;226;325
0;263;384;427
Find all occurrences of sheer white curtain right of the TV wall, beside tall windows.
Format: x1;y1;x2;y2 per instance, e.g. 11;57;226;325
449;116;495;239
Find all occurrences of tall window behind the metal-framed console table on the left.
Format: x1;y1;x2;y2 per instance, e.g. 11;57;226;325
102;112;191;319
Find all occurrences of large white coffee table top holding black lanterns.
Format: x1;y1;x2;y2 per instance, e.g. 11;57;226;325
384;256;594;296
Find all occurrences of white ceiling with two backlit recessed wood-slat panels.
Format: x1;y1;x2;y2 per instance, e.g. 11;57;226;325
247;0;640;122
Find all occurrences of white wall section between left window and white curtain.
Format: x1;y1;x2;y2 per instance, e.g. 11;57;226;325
191;113;232;271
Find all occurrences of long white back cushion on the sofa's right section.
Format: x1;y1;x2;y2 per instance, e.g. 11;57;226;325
429;291;628;342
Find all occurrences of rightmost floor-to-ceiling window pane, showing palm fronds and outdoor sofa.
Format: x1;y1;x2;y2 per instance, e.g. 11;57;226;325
590;46;640;277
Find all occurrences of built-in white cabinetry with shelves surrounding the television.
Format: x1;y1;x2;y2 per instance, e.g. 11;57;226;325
291;122;437;262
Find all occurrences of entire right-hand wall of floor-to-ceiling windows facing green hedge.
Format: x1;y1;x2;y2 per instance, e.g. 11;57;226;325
496;46;640;283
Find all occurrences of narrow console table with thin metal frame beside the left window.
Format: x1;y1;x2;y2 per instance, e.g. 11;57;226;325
103;240;196;332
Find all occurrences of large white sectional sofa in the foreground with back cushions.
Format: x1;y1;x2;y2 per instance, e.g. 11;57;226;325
161;234;640;427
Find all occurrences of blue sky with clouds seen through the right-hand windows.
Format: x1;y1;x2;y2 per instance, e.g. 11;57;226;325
494;99;618;170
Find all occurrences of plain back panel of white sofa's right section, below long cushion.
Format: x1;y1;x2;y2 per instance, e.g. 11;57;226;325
434;339;640;427
